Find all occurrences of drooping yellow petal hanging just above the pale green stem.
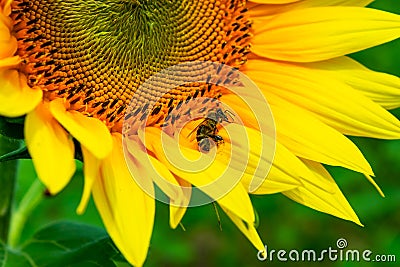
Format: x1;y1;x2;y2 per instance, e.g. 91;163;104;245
25;104;75;194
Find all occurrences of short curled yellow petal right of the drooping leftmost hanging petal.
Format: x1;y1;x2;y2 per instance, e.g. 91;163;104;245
50;99;112;159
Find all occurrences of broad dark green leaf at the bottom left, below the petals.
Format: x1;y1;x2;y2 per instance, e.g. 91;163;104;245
19;222;125;267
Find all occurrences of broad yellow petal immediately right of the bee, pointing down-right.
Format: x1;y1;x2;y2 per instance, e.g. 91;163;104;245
214;122;302;194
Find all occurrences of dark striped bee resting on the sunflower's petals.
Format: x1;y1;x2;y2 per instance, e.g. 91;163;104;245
189;108;232;153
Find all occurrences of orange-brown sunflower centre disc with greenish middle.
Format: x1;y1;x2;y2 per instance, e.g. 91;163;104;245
11;0;251;131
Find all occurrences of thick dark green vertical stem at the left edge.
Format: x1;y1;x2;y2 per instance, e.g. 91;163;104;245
0;135;20;243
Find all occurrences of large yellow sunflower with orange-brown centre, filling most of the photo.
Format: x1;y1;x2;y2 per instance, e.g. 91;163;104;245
0;0;400;266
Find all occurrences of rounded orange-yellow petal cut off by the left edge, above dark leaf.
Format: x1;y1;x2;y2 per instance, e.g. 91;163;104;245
0;70;43;117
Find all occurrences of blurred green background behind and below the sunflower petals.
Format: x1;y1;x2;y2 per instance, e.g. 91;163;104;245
12;0;400;266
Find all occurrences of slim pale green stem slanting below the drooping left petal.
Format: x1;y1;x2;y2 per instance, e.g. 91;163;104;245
8;179;45;248
